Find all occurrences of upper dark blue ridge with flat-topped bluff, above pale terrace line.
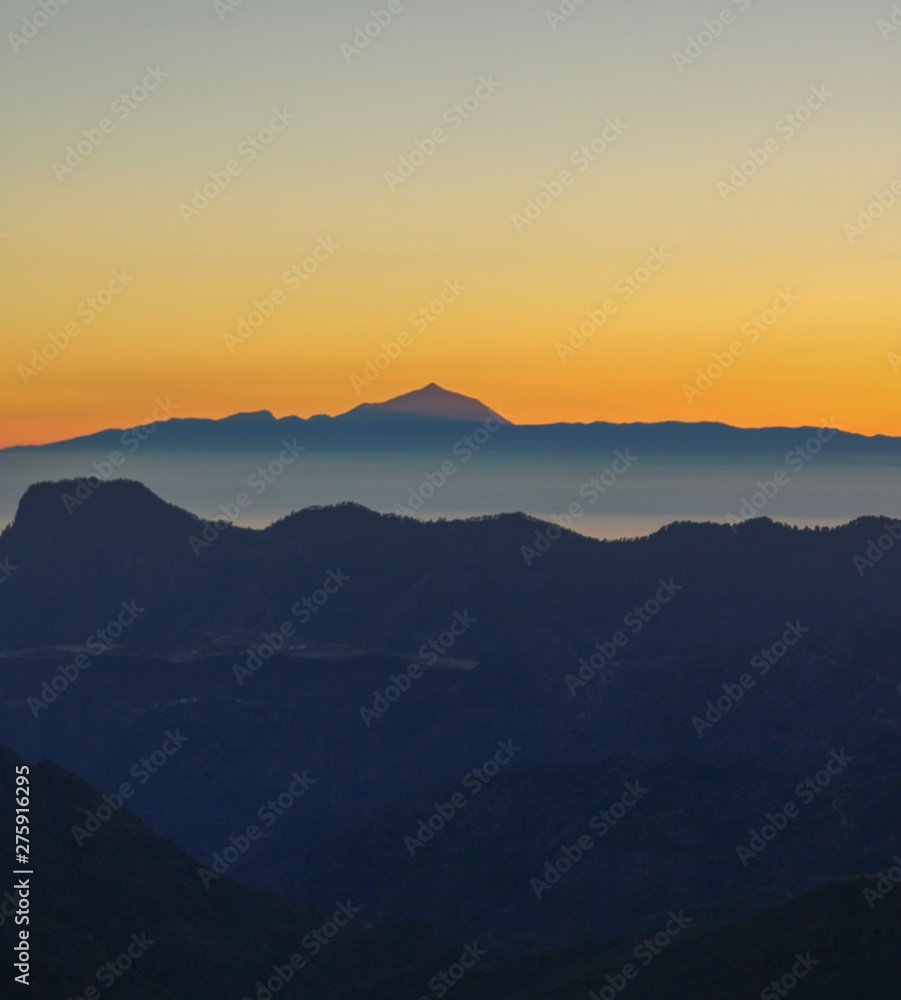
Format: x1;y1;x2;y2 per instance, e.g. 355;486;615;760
0;481;901;665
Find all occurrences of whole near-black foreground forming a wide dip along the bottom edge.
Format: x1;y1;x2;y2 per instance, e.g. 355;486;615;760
0;748;901;1000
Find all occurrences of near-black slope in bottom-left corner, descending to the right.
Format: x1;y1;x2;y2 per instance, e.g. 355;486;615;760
0;747;430;1000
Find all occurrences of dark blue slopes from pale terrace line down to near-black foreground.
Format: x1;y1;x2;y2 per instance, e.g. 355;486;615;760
0;616;901;953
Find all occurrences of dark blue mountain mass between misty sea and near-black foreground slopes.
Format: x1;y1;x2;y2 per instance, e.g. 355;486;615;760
0;481;901;954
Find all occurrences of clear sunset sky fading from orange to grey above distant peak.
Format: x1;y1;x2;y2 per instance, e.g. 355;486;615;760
0;0;901;446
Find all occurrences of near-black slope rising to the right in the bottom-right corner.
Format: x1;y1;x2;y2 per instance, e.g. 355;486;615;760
461;879;901;1000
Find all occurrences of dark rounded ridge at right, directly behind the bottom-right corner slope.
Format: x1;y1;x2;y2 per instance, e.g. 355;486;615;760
291;740;901;950
